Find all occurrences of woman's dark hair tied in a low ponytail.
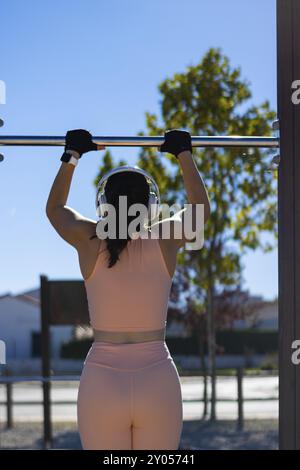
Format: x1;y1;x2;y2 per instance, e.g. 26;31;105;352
91;171;149;268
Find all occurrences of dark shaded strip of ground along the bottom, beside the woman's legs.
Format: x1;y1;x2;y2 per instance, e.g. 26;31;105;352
0;420;278;450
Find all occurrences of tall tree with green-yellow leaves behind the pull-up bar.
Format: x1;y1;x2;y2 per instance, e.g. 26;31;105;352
94;48;277;420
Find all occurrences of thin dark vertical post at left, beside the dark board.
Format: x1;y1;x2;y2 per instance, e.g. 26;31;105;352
40;276;52;449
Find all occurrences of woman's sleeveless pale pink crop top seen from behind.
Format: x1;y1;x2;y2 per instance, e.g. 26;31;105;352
84;237;172;332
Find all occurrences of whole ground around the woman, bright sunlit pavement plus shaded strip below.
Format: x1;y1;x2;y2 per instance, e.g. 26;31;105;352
0;377;278;450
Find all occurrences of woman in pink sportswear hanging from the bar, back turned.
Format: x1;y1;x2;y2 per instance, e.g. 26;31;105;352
46;129;210;450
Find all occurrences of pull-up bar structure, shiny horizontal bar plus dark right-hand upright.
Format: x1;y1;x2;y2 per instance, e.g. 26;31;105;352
0;0;300;450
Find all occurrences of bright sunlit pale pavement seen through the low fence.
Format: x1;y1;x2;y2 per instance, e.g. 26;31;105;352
0;376;278;422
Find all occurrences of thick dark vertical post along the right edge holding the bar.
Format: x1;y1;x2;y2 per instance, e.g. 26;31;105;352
277;0;300;450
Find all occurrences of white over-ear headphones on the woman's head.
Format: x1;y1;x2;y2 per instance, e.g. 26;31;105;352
96;165;160;220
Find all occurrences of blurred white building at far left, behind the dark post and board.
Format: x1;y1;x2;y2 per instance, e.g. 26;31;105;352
0;289;73;360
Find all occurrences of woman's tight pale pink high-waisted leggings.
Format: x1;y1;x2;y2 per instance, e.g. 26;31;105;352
77;341;183;450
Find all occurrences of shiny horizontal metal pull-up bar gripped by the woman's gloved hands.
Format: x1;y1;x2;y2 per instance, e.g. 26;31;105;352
0;135;279;148
